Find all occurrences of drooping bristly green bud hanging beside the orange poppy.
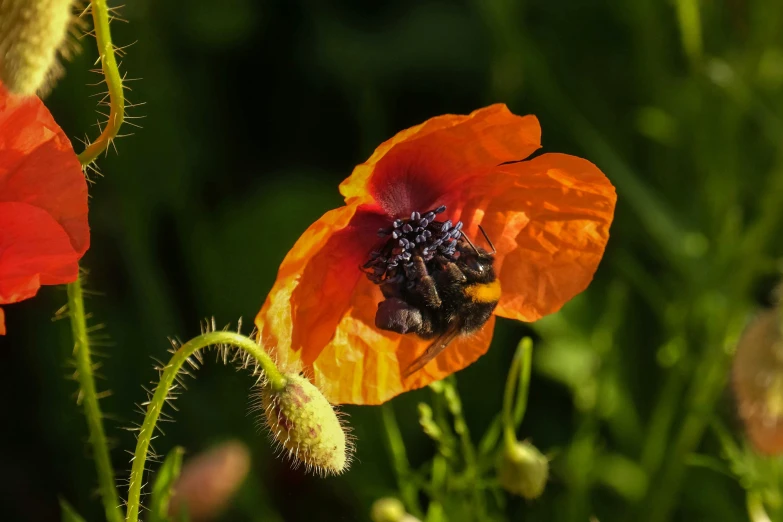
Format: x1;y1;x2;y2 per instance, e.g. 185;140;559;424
261;374;351;475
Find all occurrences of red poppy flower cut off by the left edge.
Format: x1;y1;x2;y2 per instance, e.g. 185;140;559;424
0;84;90;334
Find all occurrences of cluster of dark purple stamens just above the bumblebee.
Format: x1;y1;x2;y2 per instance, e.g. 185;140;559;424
362;205;462;284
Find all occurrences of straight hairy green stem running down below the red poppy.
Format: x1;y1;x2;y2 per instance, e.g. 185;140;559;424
68;279;122;522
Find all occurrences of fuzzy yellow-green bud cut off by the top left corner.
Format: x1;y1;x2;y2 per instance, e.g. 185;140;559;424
0;0;72;96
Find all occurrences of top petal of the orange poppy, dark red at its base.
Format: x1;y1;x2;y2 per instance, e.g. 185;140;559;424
340;104;541;217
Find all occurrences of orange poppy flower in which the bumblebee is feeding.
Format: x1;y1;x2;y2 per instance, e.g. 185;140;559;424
256;105;616;404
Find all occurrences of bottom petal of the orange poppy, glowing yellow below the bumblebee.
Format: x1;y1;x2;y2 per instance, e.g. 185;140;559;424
307;277;495;404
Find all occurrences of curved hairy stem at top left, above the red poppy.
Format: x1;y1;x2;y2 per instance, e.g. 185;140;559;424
79;0;125;165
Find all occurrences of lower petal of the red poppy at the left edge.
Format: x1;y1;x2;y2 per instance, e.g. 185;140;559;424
0;202;81;304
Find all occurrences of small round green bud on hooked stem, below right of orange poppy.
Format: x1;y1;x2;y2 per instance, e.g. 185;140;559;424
498;442;549;499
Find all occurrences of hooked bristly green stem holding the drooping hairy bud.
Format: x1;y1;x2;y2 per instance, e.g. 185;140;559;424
127;332;286;522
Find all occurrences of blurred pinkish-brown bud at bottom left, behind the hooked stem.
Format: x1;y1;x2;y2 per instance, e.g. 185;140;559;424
169;441;250;520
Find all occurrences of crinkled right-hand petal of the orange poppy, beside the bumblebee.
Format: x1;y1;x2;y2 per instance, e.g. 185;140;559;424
443;154;617;321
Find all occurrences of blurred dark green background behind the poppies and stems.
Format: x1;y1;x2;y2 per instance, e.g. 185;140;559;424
0;0;783;522
